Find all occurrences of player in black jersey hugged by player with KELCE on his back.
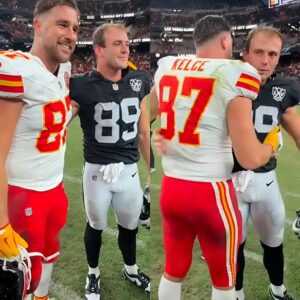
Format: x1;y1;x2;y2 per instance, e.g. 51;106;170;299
233;27;300;300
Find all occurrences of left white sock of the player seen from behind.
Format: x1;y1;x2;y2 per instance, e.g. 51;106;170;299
158;276;182;300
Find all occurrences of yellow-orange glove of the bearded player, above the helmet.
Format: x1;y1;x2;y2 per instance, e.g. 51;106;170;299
0;223;28;259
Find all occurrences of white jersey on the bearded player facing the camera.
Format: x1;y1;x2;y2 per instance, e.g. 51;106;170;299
0;51;71;191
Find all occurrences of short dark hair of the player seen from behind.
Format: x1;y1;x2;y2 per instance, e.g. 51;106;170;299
193;15;231;47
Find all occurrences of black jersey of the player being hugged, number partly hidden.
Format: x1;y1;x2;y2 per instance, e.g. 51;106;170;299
233;74;300;173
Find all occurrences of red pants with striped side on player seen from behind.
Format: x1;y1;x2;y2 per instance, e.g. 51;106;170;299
161;176;242;288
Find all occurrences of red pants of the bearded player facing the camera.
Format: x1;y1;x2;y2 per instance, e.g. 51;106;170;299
8;183;68;293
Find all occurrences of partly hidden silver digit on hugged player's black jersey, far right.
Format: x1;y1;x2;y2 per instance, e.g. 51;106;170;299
254;105;279;133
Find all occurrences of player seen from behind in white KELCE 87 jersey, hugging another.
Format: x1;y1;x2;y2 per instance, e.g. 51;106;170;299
151;16;278;300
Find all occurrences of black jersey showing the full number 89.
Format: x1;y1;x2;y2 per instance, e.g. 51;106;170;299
70;69;150;165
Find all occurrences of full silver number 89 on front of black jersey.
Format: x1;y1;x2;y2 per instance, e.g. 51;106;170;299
94;97;141;143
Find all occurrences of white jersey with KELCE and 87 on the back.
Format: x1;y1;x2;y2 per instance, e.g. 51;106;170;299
155;56;260;181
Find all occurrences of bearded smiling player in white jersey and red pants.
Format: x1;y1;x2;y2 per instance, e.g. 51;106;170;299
0;0;79;300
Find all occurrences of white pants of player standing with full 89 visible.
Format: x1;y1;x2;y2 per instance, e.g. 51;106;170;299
83;163;143;230
